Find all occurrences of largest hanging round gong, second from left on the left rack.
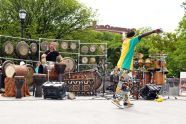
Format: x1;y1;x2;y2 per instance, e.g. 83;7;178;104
16;41;29;58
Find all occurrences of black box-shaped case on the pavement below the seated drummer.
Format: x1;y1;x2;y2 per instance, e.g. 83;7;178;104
43;81;66;99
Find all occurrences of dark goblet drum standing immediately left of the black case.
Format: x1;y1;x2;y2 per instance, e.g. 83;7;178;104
33;74;46;97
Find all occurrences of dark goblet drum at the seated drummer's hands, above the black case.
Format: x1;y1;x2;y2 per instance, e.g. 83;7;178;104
55;63;66;82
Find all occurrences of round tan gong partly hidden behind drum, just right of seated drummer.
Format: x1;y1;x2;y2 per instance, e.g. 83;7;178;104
62;57;75;72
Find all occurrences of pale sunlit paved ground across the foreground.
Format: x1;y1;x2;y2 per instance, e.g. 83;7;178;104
0;96;186;124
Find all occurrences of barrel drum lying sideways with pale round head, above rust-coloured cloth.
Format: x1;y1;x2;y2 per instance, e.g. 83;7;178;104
5;64;29;78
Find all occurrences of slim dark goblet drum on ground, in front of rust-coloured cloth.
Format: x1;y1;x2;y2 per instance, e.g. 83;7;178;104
14;76;25;98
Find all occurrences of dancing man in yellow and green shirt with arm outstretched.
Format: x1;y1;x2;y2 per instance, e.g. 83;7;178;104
112;29;162;106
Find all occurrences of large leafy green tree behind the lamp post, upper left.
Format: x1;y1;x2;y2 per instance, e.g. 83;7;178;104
0;0;93;39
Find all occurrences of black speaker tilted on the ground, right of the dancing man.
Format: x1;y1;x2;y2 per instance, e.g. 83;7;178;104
140;84;160;100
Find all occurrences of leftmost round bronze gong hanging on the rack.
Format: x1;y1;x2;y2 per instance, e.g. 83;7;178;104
3;41;14;55
